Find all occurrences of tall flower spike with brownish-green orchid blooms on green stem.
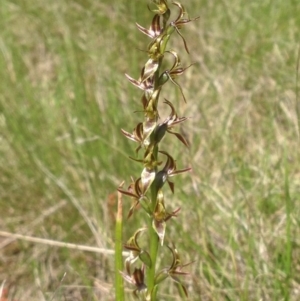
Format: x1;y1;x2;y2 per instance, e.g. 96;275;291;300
116;0;198;301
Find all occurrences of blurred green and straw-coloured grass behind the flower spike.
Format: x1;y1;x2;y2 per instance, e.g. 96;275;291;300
0;0;300;301
